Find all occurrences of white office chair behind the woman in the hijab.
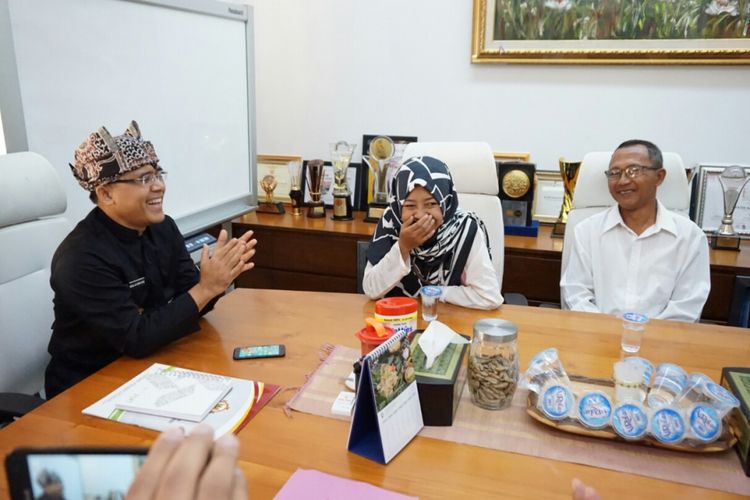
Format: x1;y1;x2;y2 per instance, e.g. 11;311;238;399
402;142;505;289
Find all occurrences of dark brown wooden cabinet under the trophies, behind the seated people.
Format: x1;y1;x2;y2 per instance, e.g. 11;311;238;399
232;212;750;322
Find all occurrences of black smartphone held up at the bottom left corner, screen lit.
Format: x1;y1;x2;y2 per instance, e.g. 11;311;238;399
5;447;148;500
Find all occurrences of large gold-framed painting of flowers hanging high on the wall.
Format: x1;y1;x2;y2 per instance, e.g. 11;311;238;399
471;0;750;65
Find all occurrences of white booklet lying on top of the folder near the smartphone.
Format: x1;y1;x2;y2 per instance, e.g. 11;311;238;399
114;363;232;422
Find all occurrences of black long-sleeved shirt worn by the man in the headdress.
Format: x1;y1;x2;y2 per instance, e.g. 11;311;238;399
45;208;214;398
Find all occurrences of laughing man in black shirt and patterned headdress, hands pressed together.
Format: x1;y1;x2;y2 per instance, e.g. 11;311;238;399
45;122;256;398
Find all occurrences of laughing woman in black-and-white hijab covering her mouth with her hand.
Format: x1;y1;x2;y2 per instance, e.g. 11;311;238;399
362;156;503;309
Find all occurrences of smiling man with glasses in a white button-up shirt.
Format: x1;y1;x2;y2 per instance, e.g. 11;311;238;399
560;140;711;322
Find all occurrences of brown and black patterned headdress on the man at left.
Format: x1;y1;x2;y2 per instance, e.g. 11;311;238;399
70;121;159;191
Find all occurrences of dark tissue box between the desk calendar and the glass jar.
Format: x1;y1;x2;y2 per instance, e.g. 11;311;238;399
411;333;469;426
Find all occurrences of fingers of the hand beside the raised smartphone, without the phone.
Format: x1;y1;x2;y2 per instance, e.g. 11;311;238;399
126;424;247;500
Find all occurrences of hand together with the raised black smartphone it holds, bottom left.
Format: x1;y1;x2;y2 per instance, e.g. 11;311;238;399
5;424;247;500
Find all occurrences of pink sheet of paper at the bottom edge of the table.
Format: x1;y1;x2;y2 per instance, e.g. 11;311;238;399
274;469;417;500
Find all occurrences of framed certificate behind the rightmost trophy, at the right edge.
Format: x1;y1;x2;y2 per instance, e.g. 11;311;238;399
694;165;750;236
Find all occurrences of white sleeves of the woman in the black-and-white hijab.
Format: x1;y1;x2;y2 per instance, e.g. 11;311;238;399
362;231;503;309
